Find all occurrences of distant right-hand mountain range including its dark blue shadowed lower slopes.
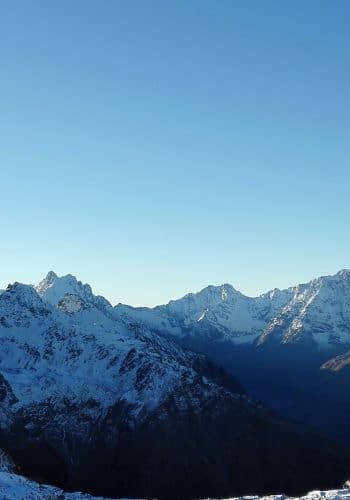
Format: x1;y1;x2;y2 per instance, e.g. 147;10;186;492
115;270;350;443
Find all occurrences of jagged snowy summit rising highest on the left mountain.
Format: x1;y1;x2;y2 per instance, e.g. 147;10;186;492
35;271;111;308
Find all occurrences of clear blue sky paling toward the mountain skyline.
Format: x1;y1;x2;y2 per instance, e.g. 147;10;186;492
0;0;350;305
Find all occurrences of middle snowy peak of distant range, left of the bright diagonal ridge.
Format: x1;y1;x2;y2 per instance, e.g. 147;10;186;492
114;284;290;344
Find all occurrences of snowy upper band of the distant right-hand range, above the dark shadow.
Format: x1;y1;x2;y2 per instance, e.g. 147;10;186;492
114;270;350;349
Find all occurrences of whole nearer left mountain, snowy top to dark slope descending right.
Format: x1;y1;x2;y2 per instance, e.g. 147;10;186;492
0;273;350;499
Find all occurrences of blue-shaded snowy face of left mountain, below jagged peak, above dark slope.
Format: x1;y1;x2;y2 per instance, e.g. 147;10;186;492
0;283;213;413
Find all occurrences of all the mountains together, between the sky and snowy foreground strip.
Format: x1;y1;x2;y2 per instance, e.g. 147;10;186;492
0;271;350;499
